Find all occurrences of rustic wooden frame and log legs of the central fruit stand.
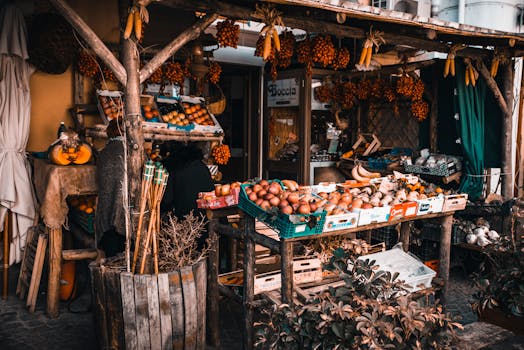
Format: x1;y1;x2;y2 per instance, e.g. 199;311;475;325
207;207;455;349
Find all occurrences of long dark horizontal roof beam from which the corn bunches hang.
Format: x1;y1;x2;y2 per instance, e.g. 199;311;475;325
161;0;492;57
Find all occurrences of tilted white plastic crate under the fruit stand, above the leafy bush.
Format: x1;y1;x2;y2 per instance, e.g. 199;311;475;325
359;248;437;292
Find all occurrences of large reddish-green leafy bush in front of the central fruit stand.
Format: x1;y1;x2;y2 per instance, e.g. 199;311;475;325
256;249;461;349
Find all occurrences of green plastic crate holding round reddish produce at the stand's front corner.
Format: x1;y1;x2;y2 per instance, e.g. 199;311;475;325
238;181;326;238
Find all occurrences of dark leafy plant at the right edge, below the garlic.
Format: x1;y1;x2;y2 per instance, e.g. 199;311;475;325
472;236;524;314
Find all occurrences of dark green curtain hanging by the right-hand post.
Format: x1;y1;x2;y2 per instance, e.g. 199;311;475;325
455;62;486;200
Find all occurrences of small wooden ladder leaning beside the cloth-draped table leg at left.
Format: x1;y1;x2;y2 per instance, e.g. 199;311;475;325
16;227;47;312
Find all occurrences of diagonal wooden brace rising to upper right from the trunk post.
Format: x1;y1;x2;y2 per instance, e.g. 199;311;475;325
140;13;218;83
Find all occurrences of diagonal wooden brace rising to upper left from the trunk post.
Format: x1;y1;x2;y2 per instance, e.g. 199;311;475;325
49;0;127;86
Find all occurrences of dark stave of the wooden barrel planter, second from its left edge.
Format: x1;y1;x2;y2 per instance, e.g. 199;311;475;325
104;268;125;349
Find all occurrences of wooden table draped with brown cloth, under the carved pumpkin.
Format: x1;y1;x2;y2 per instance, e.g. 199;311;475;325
34;159;97;318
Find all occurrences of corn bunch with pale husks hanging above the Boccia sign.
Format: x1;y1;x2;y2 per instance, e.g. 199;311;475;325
253;4;284;62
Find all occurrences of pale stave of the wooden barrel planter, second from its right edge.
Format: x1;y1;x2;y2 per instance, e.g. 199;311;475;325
180;266;198;350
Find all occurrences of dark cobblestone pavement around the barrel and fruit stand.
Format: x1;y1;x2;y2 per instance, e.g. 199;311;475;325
0;266;496;350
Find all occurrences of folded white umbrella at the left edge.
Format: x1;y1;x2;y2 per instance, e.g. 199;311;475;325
0;5;36;264
